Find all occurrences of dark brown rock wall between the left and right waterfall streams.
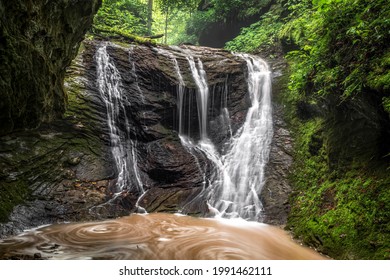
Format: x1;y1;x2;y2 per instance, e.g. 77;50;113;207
76;41;249;217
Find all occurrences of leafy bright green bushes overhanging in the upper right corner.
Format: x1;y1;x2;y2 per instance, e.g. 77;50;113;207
280;0;390;99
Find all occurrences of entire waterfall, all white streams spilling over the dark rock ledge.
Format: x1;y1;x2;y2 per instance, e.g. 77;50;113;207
96;43;273;220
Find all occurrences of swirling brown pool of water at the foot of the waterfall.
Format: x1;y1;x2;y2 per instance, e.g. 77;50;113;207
0;213;324;260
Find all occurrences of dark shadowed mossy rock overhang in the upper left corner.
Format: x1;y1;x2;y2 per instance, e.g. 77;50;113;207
0;0;101;135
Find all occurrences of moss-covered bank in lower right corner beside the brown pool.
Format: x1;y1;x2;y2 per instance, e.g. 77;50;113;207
289;163;390;259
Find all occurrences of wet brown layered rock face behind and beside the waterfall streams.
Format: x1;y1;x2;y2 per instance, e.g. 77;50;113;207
0;40;291;236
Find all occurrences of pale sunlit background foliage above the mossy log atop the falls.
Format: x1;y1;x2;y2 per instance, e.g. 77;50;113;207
93;0;200;44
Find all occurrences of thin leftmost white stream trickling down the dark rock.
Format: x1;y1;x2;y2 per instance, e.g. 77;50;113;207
96;45;144;194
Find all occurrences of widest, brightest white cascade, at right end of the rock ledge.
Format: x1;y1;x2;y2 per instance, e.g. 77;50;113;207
209;55;273;220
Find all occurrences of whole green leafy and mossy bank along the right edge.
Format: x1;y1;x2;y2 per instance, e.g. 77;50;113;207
279;0;390;259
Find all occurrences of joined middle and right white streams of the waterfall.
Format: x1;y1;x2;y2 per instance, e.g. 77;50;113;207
171;50;273;220
